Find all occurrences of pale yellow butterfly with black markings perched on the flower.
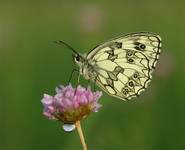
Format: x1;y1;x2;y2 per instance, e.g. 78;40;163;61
57;32;162;100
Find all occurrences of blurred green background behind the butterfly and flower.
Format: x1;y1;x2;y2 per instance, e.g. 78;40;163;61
0;0;185;150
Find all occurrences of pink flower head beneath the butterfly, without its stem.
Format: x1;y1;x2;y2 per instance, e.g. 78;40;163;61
42;85;102;124
